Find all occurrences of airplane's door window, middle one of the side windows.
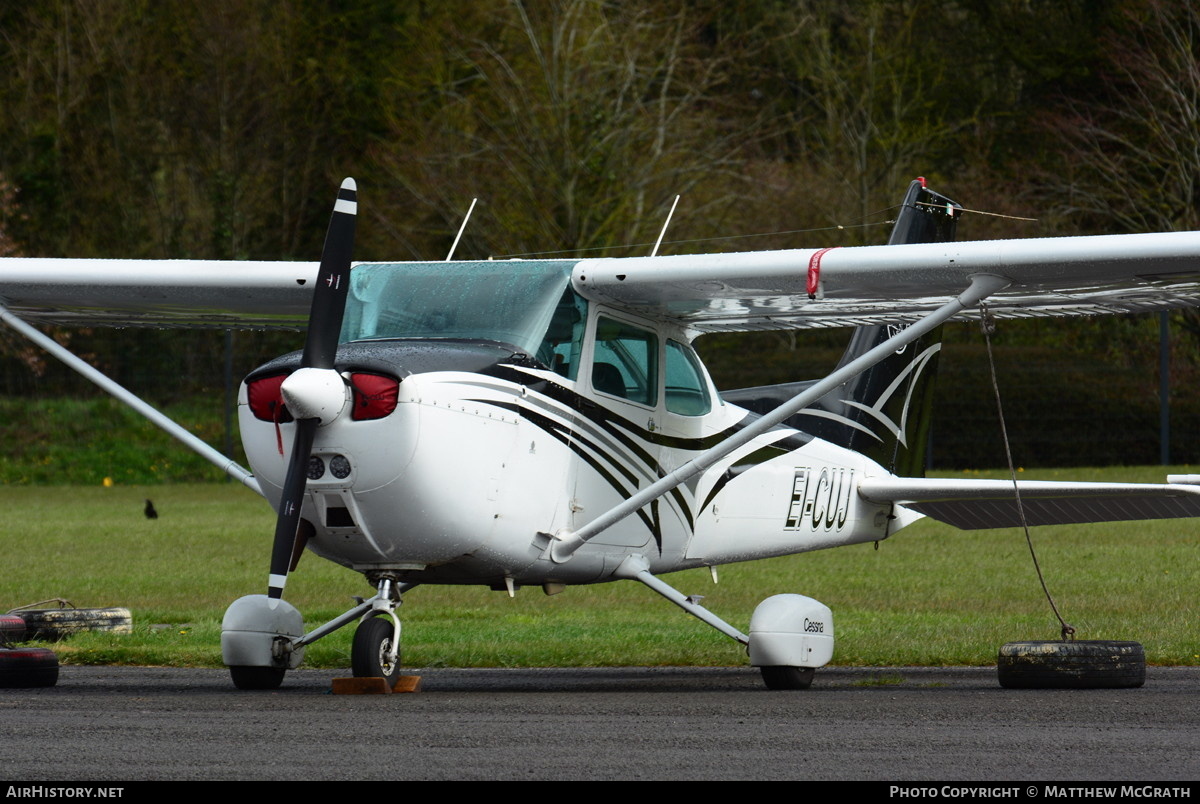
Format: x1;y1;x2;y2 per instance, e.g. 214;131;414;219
592;316;659;407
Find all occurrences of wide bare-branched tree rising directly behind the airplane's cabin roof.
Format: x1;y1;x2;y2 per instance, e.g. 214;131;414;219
377;0;757;257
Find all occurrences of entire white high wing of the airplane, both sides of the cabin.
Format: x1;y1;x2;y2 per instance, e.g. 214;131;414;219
7;232;1200;332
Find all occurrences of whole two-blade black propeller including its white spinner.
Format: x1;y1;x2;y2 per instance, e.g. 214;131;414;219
266;179;358;599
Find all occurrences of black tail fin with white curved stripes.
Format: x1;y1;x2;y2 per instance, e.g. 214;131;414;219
721;179;961;476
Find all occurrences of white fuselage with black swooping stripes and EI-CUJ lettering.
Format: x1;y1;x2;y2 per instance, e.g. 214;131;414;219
239;264;898;587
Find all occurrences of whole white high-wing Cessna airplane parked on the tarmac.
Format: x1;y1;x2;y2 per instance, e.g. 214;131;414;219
0;180;1200;689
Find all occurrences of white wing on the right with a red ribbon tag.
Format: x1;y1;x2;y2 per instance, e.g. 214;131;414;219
575;232;1200;332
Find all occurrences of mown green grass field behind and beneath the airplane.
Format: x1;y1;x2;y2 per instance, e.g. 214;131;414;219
0;467;1200;667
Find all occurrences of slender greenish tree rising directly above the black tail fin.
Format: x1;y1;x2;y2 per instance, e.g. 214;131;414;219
729;0;983;242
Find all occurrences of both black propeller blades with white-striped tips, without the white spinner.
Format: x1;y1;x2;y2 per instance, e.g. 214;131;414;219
266;179;358;599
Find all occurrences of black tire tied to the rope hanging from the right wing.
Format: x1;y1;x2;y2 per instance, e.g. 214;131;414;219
996;640;1146;690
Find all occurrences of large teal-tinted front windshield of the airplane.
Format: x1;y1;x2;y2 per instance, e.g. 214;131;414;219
341;260;575;355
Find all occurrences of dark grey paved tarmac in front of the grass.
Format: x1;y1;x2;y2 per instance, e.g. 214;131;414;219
0;667;1200;782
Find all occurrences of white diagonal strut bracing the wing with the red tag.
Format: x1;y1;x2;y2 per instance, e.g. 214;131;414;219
550;274;1009;563
